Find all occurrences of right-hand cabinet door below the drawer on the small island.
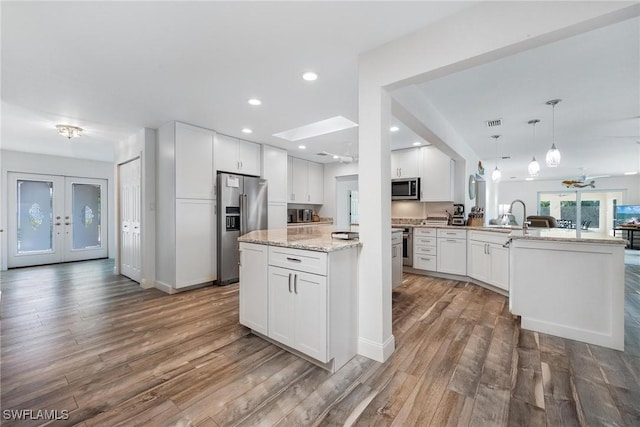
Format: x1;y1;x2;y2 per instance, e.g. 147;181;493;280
293;272;329;362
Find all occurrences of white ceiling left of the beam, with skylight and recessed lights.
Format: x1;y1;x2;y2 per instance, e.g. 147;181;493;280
1;1;470;161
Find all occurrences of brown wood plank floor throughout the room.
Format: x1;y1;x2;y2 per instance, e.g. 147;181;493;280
0;258;640;427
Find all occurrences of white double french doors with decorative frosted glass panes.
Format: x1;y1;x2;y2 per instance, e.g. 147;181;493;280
7;173;108;268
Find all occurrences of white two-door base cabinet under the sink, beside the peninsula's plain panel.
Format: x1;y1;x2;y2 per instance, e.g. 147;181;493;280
467;230;509;291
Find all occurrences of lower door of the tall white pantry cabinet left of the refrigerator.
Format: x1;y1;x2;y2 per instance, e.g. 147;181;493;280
174;199;217;288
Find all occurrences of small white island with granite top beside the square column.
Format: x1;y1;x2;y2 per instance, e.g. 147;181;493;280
238;225;361;372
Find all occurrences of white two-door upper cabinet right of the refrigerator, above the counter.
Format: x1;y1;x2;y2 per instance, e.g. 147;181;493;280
287;157;324;205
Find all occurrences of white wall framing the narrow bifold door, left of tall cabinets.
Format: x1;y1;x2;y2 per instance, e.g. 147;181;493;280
115;128;156;288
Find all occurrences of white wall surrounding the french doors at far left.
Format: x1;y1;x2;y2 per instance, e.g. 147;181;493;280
0;150;116;269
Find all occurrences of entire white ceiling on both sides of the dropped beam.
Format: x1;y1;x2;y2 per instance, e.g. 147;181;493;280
0;1;640;179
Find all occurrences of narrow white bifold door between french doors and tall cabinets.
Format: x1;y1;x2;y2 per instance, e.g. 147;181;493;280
118;158;142;283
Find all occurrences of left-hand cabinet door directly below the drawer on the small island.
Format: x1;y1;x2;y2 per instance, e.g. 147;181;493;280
268;266;295;348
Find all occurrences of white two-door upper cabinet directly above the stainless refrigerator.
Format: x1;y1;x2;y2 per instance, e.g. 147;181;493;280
213;134;260;176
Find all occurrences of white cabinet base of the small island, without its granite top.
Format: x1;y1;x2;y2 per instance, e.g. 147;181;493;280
240;242;358;372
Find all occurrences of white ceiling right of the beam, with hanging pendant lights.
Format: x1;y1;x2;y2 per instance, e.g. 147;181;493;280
396;18;640;179
